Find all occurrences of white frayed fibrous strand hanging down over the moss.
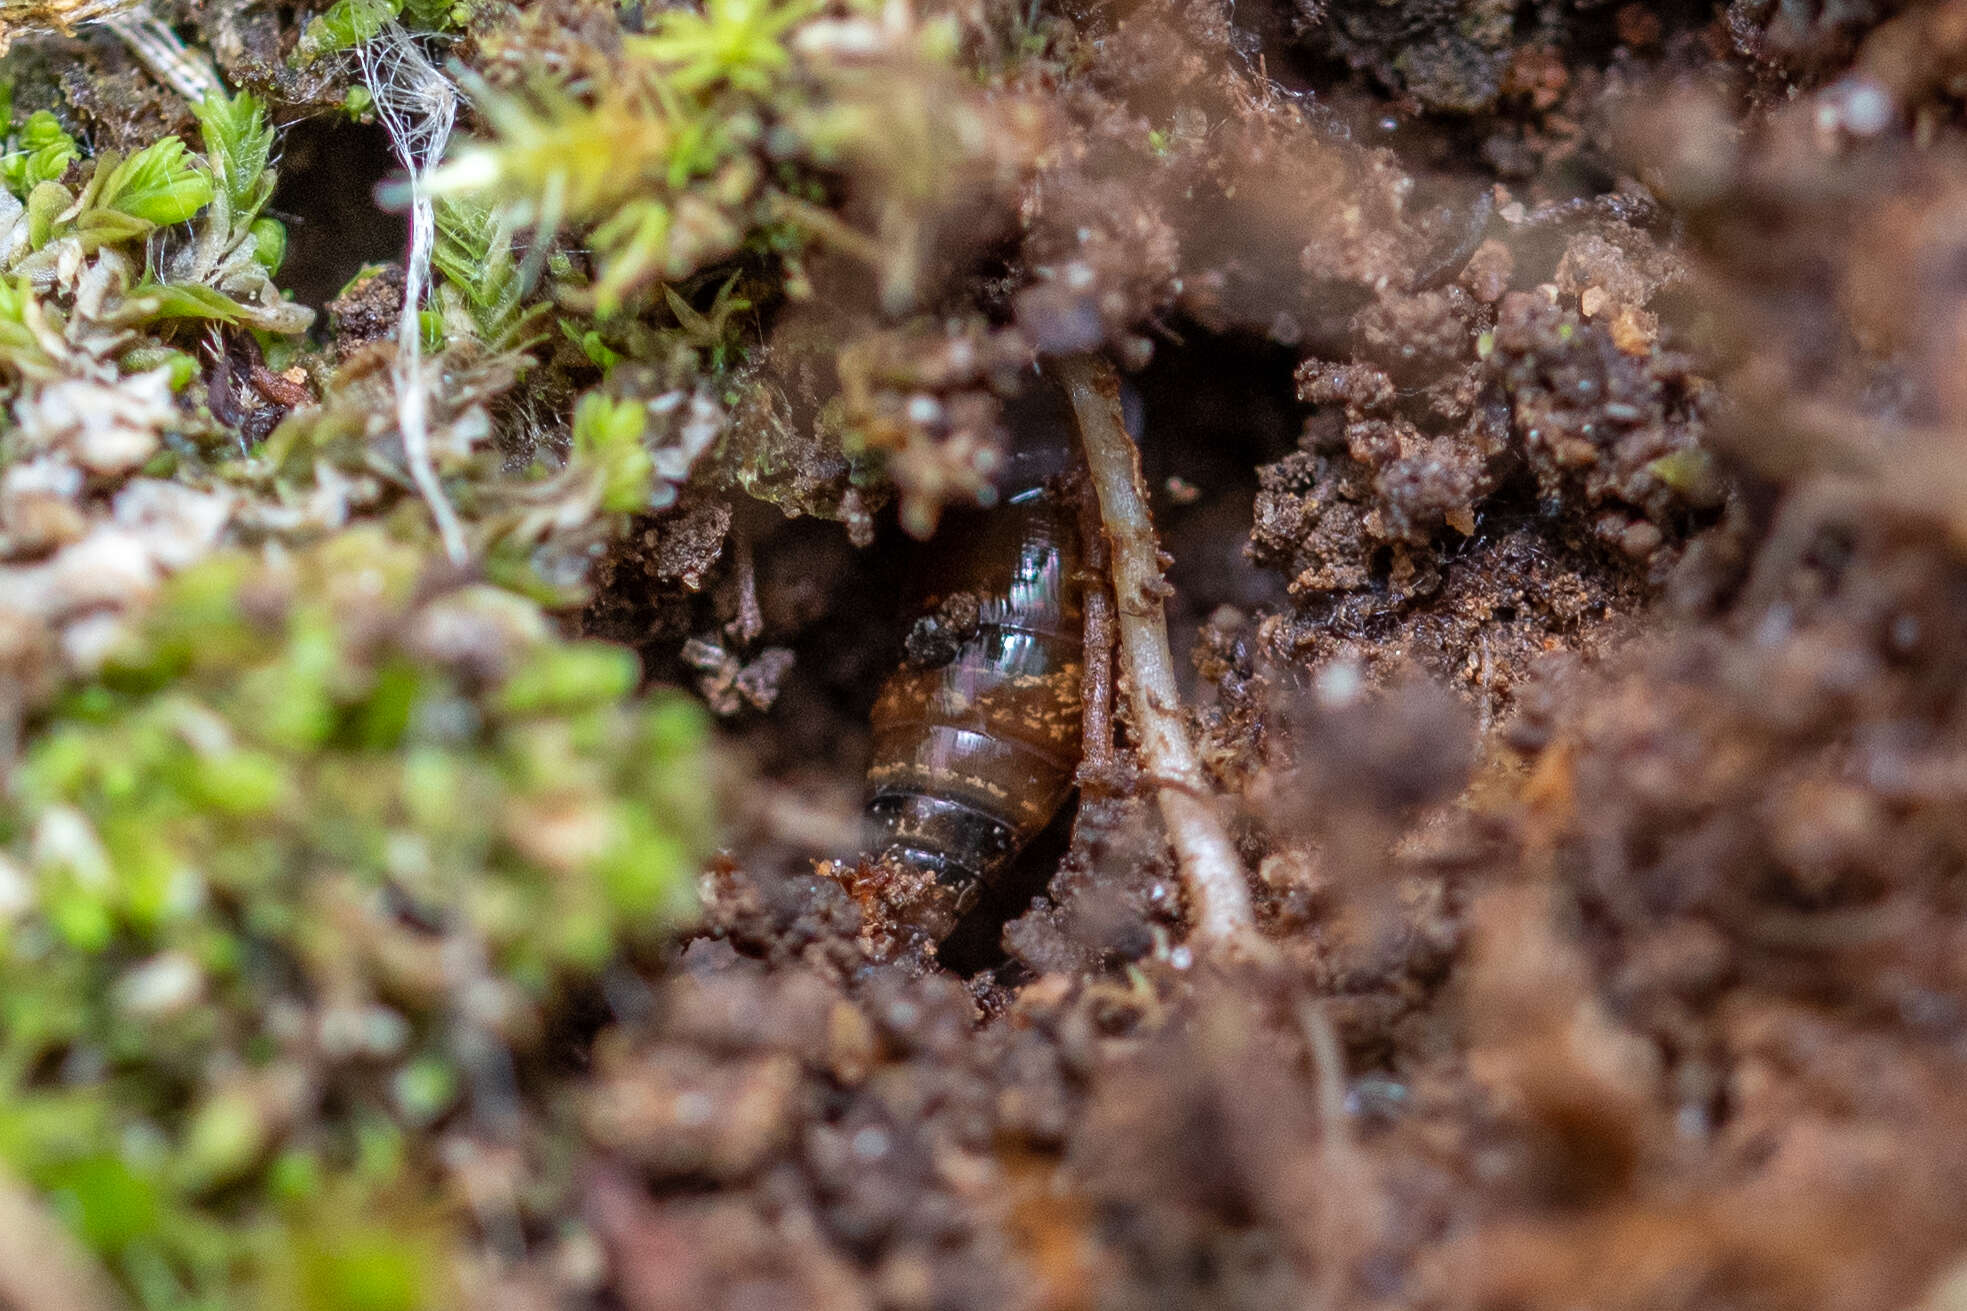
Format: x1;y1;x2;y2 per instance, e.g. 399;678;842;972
360;22;470;565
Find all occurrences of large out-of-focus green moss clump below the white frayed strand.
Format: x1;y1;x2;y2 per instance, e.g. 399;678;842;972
0;528;712;1309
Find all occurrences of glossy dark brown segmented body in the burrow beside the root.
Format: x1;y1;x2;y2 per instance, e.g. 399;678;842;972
867;433;1084;913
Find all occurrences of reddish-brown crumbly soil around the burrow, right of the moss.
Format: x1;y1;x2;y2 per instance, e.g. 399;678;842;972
546;0;1967;1311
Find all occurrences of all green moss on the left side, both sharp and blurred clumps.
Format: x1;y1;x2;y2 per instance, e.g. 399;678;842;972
0;15;844;1311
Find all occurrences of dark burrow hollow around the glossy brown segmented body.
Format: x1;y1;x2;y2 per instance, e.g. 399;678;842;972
692;323;1306;976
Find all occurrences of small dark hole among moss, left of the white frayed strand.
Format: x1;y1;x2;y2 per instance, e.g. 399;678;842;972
269;116;409;309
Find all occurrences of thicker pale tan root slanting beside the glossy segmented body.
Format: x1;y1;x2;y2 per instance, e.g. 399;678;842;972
1054;354;1255;943
